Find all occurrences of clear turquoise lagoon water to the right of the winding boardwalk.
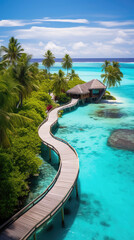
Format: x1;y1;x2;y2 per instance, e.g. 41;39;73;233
28;63;134;240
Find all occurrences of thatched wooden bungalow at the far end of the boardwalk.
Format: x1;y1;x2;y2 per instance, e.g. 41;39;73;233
67;79;106;102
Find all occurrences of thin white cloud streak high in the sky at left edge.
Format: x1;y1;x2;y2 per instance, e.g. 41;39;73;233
0;20;40;27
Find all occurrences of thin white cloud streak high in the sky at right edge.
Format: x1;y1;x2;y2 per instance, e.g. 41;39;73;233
95;21;134;27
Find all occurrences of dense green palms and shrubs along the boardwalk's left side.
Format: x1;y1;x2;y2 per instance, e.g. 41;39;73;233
0;37;83;223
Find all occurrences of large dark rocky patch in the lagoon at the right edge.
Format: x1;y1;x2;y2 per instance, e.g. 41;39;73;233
108;129;134;151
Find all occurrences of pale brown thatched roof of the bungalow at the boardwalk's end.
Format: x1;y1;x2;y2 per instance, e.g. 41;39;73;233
67;79;106;95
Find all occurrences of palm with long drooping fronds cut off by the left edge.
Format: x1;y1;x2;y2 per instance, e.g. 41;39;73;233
0;70;28;148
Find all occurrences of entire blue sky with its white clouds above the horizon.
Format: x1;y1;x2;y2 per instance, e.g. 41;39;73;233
0;0;134;58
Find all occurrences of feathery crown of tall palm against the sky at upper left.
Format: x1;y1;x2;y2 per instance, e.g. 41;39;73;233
1;37;24;65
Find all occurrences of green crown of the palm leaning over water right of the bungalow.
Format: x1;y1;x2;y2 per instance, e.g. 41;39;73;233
101;65;123;88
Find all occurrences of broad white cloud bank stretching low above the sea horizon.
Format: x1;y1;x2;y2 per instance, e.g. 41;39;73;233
10;26;134;57
